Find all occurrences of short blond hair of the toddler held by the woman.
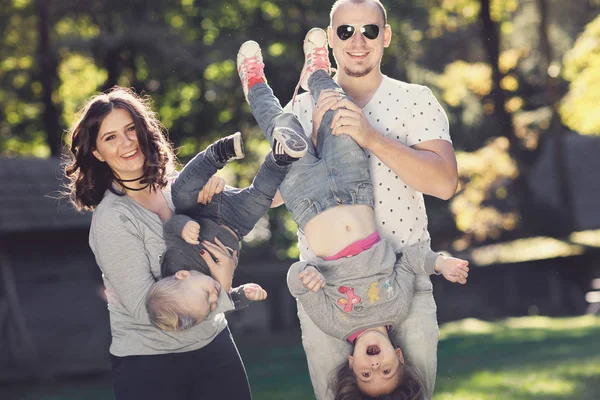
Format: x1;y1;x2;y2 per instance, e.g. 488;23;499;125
146;276;201;331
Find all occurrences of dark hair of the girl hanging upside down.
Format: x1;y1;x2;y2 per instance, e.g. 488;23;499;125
331;338;426;400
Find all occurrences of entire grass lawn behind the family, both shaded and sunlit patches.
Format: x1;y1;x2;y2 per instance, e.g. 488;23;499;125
0;316;600;400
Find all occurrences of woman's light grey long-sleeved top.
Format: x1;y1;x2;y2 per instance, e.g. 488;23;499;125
89;190;234;357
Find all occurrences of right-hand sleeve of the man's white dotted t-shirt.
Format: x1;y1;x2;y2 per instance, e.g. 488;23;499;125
405;87;452;146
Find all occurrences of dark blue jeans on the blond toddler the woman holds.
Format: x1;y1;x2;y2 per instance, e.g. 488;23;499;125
171;145;290;240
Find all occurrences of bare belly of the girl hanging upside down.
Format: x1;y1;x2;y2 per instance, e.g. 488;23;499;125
304;205;376;257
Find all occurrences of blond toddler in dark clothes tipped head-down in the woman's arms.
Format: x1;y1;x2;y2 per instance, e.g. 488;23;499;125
146;107;307;331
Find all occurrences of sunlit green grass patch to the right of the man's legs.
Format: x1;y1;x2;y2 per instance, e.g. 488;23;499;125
434;316;600;400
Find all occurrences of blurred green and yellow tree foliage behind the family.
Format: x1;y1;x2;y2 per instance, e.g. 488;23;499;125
0;0;600;250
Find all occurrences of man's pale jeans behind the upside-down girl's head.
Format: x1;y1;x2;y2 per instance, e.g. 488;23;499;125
296;275;439;400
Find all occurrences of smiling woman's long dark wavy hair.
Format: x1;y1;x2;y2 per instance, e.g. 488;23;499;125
63;86;175;211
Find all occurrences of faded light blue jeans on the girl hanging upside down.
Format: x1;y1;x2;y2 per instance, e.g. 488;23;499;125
248;71;373;229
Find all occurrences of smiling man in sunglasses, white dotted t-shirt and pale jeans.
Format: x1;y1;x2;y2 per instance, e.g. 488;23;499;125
288;0;458;400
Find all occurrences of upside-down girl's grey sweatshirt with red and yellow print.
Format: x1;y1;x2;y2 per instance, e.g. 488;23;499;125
287;240;438;340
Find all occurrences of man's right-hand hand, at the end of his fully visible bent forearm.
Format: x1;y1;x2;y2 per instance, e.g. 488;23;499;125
331;98;377;149
